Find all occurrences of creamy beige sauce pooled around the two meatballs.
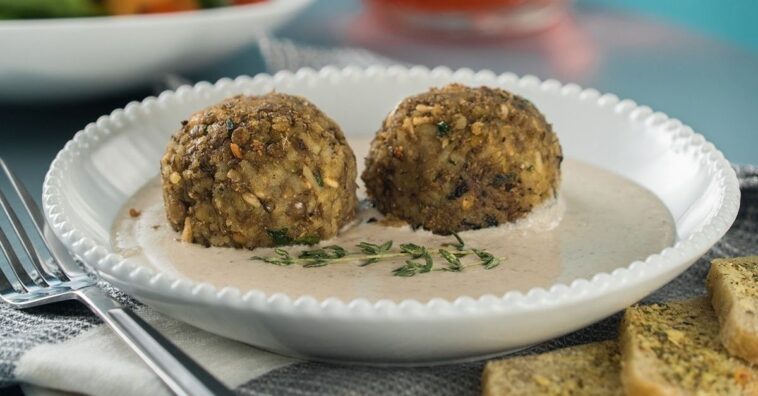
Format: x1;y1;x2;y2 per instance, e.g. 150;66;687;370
111;138;675;301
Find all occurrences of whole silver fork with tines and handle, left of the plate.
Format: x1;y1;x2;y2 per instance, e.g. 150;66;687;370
0;159;234;395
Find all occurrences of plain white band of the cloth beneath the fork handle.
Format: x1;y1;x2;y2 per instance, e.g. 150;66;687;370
15;307;297;396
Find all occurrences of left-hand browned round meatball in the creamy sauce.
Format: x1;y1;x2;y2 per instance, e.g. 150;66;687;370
161;93;357;249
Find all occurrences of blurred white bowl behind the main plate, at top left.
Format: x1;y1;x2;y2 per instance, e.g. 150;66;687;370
0;0;312;101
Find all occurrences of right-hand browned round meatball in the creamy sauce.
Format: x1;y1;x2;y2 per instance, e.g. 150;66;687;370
362;84;563;234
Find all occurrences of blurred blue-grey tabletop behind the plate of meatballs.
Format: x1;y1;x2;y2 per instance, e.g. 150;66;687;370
0;0;758;203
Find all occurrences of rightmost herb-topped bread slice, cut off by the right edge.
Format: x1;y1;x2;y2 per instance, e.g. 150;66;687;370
707;256;758;363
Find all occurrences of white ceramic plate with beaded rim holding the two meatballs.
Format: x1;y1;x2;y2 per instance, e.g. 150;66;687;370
43;67;739;364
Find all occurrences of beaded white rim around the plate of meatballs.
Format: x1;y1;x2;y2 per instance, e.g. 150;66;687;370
43;65;739;317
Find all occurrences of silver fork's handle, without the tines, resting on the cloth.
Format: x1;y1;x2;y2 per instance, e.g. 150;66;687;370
78;287;234;396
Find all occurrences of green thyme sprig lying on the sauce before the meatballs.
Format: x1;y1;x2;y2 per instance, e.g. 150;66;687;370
250;233;500;277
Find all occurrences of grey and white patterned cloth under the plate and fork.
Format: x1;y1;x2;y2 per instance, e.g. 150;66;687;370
0;39;758;396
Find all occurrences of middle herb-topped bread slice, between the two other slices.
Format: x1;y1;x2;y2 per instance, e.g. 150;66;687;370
620;298;758;396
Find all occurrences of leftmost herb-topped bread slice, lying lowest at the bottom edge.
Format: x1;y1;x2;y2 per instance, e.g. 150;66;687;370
482;341;623;396
